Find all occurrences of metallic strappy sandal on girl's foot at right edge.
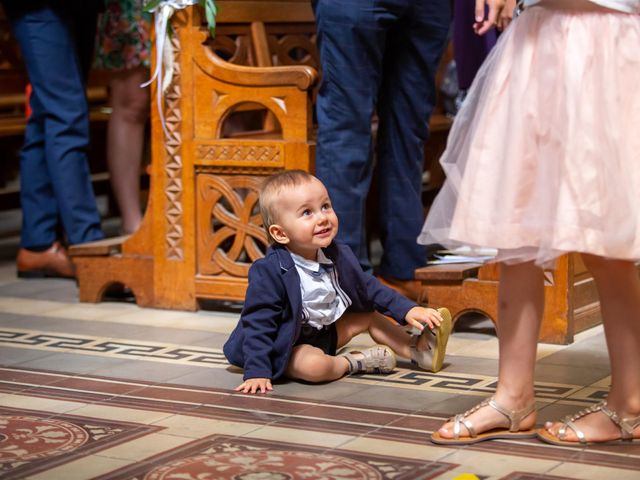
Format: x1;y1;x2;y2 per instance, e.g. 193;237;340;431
538;400;640;447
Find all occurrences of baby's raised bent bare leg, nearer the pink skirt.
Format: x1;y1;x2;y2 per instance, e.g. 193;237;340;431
336;312;411;358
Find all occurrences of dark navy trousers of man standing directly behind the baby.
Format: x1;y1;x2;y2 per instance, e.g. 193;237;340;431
313;0;451;279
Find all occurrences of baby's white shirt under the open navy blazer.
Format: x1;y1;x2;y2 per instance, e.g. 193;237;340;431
289;250;351;330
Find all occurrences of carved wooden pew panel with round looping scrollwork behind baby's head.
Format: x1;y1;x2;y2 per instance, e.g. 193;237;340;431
196;174;267;278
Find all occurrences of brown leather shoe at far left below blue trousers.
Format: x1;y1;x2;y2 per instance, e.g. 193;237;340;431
16;242;76;278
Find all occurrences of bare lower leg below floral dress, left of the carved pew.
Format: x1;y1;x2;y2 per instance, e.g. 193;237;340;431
107;67;149;233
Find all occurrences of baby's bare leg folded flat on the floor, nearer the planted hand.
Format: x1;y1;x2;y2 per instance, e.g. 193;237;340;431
286;345;349;383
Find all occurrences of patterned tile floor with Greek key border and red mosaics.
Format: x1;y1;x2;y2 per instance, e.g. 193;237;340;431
0;228;640;480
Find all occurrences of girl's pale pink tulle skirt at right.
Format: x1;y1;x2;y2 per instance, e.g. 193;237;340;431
418;0;640;265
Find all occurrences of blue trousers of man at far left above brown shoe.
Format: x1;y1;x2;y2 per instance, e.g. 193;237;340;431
7;0;103;249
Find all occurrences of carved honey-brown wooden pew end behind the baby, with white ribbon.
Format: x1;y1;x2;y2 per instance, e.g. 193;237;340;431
71;0;450;310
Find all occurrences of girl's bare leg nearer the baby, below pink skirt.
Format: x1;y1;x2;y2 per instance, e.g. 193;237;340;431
438;262;544;438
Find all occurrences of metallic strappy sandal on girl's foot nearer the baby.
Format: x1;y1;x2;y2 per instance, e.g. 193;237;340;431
431;397;536;445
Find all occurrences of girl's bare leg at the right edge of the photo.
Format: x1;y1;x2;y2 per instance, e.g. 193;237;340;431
550;255;640;442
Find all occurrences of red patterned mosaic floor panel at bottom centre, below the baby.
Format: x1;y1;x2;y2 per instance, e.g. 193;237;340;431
96;435;452;480
